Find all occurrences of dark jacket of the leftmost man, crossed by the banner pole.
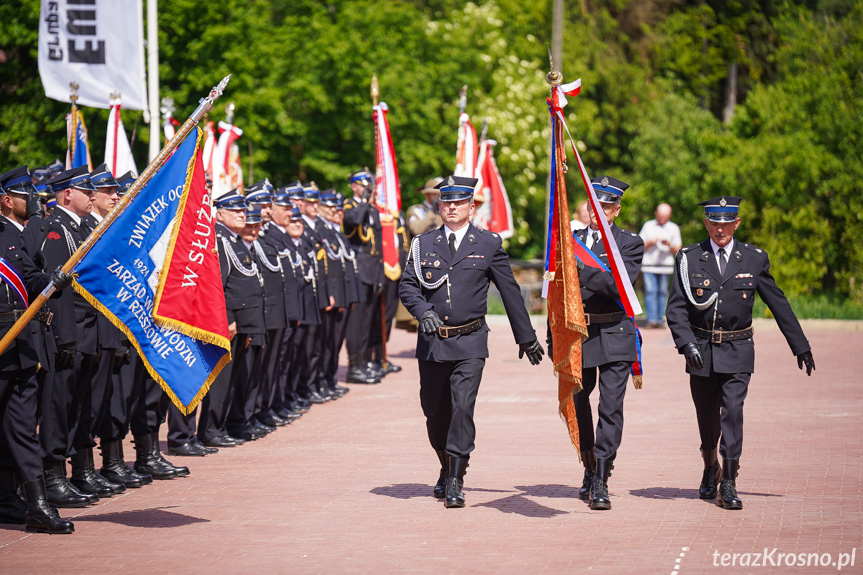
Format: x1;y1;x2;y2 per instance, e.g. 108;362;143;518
0;218;56;371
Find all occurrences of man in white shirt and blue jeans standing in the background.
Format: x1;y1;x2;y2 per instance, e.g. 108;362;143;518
638;204;683;327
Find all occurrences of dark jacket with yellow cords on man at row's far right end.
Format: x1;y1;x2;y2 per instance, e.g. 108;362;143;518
342;198;385;285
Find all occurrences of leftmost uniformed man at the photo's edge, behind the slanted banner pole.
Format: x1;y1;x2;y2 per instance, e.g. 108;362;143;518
0;166;75;533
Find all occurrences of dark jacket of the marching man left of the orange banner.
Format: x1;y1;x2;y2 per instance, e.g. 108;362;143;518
399;224;536;361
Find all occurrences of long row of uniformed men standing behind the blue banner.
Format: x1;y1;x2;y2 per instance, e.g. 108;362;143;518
0;162;422;533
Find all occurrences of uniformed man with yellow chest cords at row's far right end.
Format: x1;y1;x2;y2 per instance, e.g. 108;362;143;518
342;169;385;383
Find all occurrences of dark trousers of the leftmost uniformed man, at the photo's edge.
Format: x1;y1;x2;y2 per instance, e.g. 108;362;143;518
0;366;42;481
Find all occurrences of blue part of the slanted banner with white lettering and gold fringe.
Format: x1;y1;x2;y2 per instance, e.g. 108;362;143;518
74;129;230;413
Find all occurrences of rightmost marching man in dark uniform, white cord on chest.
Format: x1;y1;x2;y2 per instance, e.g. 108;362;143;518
666;196;815;509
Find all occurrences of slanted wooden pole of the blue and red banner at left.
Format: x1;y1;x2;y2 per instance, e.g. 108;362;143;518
0;74;231;354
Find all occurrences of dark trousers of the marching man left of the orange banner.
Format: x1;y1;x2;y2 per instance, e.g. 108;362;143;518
418;358;485;457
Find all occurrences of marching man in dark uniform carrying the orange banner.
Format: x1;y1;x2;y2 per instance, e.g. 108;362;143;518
548;176;644;509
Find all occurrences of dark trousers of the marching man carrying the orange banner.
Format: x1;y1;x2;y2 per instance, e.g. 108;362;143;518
575;361;632;460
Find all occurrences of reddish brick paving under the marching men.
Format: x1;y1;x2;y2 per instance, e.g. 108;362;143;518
0;321;863;575
